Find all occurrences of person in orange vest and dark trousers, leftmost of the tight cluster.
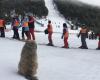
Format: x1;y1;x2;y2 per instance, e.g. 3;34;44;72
12;16;20;40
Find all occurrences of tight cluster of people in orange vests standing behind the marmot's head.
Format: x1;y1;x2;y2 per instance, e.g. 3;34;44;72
11;16;35;40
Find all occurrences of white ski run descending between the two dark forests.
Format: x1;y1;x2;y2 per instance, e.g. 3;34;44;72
41;0;66;32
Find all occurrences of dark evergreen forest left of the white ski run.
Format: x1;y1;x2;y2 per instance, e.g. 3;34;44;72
0;0;48;21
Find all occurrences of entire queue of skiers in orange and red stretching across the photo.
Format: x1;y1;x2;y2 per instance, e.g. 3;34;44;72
0;15;100;50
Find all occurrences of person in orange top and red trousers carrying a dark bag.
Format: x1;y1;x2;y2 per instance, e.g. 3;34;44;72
47;20;53;46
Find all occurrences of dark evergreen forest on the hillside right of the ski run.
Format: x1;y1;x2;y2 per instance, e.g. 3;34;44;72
54;0;100;33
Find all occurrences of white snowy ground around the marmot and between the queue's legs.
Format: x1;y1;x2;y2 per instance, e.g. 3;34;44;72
0;32;100;80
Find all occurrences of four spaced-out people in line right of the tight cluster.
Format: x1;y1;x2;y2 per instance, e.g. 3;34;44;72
45;21;100;50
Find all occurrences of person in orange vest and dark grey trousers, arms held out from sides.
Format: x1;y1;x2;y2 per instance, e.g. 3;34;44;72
78;25;88;49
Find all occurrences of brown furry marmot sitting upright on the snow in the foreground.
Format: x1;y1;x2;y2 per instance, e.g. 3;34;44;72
18;41;38;78
